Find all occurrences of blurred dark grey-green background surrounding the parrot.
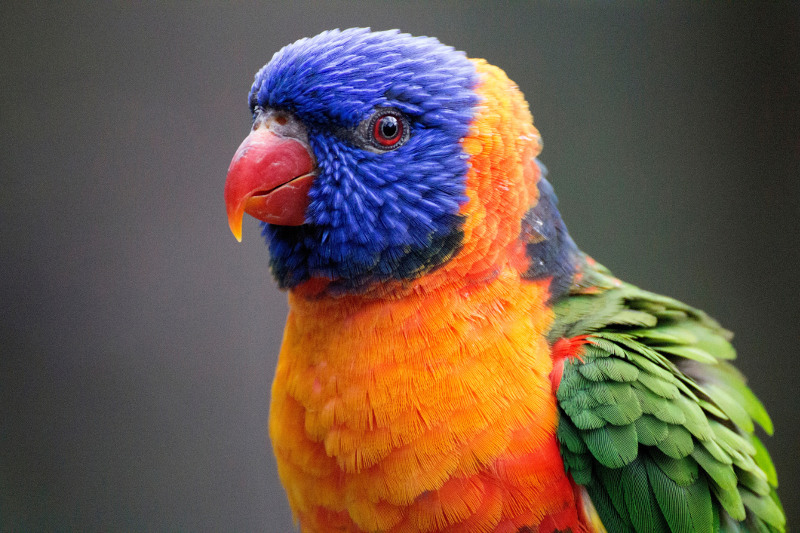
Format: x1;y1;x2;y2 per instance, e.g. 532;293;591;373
0;2;800;532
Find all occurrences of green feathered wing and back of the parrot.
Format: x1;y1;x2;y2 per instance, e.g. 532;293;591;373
549;260;786;533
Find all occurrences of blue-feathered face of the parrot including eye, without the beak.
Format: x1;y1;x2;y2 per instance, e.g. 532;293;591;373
250;29;478;292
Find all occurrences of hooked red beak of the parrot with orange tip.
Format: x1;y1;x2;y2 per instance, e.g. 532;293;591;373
225;124;315;242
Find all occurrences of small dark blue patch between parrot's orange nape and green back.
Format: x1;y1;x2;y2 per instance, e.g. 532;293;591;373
522;160;579;301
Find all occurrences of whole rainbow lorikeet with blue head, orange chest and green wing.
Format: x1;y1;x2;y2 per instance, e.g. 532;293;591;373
225;29;785;533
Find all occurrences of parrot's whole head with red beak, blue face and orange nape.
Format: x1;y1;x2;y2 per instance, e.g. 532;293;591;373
225;29;552;294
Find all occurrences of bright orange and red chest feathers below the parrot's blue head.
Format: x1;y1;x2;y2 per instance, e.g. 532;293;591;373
270;270;582;532
